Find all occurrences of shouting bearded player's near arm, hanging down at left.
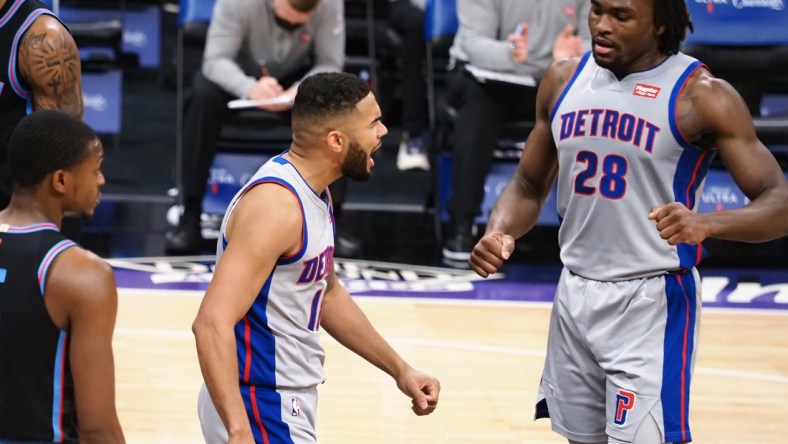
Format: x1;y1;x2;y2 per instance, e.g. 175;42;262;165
192;184;303;440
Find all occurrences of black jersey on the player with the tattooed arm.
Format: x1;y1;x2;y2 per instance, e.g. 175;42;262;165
0;0;58;163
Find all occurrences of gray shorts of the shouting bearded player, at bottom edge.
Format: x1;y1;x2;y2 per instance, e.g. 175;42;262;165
197;384;317;444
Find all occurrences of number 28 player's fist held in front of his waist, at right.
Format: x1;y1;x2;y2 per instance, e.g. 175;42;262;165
648;202;709;245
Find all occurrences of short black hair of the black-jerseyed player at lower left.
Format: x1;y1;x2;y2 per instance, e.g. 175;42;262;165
8;110;97;188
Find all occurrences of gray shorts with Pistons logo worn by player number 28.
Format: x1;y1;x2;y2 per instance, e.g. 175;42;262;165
536;269;701;442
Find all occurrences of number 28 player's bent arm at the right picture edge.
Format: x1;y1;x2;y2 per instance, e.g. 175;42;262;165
650;70;788;245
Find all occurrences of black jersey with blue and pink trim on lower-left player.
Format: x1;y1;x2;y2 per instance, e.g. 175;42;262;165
0;223;77;442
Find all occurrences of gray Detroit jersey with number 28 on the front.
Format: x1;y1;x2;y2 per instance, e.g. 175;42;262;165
550;52;713;281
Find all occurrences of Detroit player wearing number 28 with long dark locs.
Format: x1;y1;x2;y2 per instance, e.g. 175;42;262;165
469;0;788;444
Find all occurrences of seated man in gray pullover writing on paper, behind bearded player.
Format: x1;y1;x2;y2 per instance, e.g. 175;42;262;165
166;0;345;254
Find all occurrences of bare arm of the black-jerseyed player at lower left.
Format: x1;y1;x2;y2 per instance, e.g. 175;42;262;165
44;247;125;443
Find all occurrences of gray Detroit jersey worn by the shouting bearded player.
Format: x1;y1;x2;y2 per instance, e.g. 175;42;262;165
216;155;334;389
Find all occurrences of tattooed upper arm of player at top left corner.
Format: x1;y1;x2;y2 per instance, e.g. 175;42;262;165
18;15;84;119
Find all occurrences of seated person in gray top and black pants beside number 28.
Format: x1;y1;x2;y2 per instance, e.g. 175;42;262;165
443;0;591;267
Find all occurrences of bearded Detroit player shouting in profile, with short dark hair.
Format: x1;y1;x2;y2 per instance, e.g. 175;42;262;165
193;73;440;444
